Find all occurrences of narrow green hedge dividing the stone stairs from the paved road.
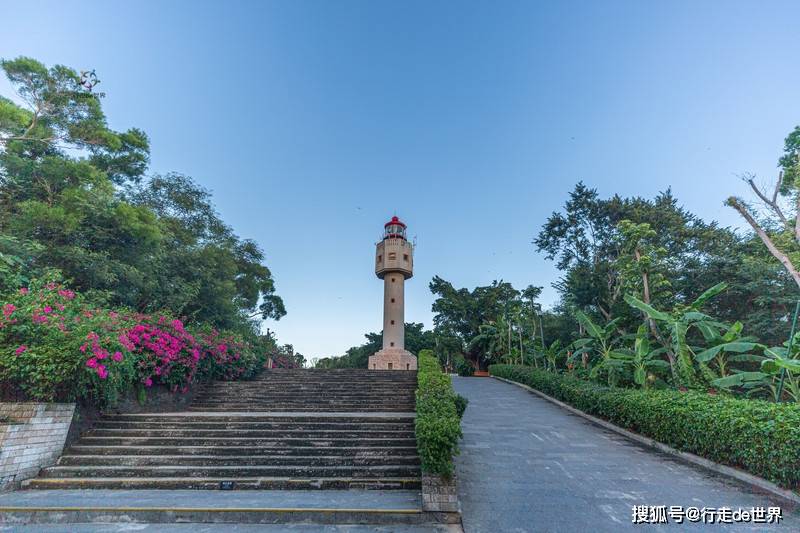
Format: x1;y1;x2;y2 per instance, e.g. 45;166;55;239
415;350;461;476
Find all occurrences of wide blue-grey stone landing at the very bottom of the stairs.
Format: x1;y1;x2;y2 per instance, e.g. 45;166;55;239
0;488;438;533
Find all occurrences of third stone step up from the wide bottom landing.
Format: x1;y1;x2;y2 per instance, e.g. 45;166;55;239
58;451;419;466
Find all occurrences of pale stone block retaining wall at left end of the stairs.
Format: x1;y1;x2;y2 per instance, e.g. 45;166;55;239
0;402;75;491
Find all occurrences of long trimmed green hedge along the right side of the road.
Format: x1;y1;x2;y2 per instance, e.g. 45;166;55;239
489;365;800;490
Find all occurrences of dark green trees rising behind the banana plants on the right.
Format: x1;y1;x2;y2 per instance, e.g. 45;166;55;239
534;183;797;345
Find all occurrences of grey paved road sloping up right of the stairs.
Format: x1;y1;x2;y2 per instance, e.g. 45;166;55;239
453;378;800;533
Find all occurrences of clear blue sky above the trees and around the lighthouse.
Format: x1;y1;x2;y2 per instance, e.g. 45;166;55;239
0;0;800;357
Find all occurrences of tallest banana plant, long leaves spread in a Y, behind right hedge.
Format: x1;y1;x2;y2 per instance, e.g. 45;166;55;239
625;283;728;387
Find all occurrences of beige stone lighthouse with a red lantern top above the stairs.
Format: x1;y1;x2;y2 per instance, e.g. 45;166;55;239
369;216;417;370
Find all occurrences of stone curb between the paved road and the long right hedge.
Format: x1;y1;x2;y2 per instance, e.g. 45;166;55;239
492;376;800;505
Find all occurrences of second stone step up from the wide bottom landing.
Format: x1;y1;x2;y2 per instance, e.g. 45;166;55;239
41;464;419;479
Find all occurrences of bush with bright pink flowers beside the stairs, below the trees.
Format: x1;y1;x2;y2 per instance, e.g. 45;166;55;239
0;276;266;405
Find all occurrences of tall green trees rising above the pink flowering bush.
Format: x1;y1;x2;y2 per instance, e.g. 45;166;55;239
0;57;285;332
